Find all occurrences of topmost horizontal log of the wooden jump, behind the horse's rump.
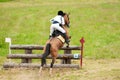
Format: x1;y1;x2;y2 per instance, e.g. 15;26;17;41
10;45;81;50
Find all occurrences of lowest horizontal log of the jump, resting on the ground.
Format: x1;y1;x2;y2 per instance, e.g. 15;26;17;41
3;63;79;69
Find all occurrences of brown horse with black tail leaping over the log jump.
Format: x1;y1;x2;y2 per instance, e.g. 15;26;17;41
39;13;70;74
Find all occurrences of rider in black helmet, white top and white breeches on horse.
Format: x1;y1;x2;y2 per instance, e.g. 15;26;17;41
49;10;69;44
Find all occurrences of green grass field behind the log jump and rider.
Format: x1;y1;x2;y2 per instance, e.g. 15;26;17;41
0;0;120;58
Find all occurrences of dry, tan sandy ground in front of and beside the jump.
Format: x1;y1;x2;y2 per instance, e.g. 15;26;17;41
0;59;120;80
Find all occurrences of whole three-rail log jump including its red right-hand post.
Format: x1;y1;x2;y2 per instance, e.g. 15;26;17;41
3;38;84;68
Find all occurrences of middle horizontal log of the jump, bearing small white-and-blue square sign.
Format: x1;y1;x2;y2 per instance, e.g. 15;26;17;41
7;54;80;59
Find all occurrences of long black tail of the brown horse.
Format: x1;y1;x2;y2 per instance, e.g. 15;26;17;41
41;43;51;66
